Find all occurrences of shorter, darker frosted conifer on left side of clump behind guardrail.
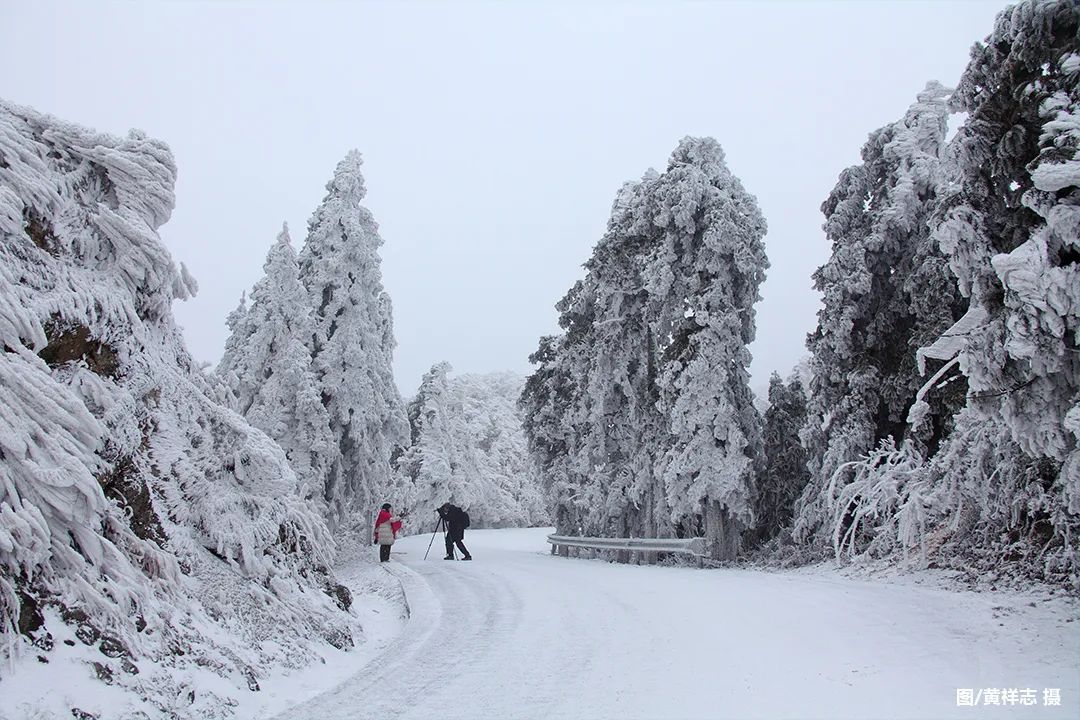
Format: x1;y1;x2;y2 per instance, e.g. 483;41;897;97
522;177;672;544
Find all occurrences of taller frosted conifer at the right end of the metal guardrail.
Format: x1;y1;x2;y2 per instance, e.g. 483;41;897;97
643;137;769;558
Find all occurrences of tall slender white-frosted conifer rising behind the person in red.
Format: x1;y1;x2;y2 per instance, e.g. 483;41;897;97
299;150;408;526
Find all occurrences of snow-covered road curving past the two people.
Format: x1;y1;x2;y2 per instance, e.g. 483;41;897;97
280;529;1080;720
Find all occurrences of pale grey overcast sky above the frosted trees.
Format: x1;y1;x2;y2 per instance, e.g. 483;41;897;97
0;0;1007;395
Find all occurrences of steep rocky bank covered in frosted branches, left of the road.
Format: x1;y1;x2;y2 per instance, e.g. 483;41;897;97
0;103;353;717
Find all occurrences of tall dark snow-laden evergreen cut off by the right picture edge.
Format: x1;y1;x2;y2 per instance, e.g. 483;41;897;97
931;0;1080;584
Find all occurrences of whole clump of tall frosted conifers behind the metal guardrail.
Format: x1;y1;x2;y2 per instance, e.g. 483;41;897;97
522;138;768;557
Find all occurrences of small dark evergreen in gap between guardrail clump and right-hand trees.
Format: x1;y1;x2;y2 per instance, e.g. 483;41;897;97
754;372;810;541
